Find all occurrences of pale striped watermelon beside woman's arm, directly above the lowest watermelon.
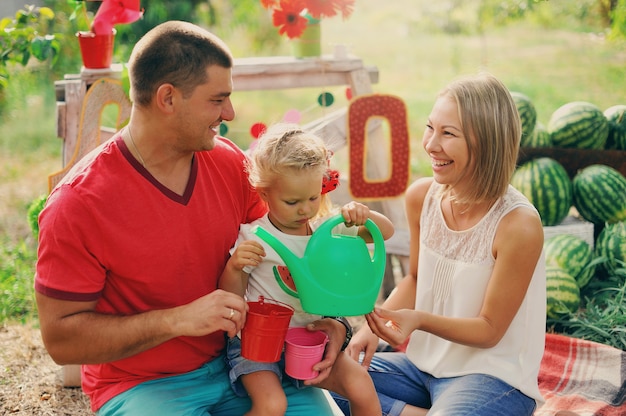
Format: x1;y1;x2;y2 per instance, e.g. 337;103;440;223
543;234;595;288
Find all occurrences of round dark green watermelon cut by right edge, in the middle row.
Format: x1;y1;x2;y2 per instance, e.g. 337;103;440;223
572;165;626;225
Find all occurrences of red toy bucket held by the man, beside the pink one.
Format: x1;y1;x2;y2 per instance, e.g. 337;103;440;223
241;297;293;363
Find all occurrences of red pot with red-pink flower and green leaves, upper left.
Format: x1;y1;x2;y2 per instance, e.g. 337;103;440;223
72;0;143;69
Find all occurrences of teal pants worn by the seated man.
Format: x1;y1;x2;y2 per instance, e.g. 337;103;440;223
96;356;333;416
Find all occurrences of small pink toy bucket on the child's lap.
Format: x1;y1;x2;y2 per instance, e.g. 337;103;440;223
285;328;328;380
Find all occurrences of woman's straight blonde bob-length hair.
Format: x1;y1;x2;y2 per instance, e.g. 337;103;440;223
439;73;522;203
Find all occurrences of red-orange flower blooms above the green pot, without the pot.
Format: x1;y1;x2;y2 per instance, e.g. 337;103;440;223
260;0;356;39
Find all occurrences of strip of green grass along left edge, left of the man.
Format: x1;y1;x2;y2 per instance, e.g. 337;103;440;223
0;67;61;324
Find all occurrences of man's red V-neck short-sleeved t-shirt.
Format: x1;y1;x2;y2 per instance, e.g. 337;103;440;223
35;135;266;410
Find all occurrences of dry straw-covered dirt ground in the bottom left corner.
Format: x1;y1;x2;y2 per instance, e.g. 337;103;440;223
0;324;94;416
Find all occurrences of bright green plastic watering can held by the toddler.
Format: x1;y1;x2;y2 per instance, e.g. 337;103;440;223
251;214;386;316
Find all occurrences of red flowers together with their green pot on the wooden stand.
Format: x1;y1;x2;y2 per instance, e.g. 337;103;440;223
260;0;356;58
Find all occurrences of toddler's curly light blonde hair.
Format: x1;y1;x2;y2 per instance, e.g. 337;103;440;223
246;123;332;218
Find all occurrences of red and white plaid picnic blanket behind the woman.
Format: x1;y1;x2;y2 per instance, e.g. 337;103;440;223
535;334;626;416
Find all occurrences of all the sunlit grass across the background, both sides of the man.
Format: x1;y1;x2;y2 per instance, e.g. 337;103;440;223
0;0;626;328
